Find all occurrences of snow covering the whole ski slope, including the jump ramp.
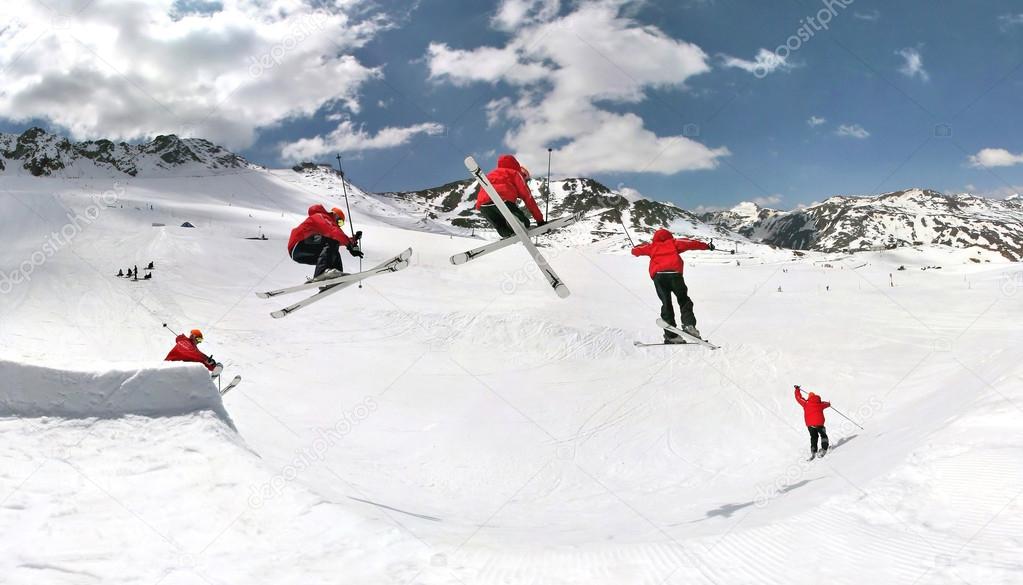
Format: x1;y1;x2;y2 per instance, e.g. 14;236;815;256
0;166;1023;585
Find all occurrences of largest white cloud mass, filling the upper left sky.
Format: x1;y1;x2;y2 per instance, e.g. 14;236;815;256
0;0;389;148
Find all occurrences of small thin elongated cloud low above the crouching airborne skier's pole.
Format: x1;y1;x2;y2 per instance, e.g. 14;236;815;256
280;121;444;161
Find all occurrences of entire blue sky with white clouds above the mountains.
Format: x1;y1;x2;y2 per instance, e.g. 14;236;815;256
0;0;1023;209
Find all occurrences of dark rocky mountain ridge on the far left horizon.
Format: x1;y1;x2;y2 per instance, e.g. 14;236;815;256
0;128;255;178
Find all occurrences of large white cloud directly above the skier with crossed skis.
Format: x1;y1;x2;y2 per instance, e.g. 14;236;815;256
427;0;729;175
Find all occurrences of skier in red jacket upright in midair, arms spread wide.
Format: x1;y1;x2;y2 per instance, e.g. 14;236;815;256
632;228;714;344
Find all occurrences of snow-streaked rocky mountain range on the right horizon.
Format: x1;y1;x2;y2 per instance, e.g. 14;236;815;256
701;188;1023;261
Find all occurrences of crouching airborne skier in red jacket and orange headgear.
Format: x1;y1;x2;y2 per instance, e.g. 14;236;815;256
287;205;363;280
